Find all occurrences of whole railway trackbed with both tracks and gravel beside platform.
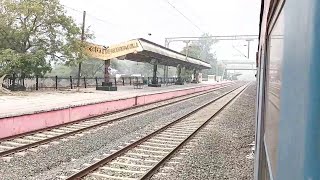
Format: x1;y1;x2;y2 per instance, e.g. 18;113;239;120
0;82;256;180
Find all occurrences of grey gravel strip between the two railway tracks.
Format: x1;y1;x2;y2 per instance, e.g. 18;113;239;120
0;83;241;180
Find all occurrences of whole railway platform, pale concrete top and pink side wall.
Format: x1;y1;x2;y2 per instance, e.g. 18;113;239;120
0;82;232;139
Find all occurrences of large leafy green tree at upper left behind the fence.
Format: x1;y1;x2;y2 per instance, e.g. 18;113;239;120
0;0;89;76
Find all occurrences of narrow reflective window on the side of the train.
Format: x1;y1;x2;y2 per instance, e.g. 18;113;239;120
264;3;284;177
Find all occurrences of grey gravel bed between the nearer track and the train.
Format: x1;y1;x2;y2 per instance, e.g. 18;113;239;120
151;85;256;180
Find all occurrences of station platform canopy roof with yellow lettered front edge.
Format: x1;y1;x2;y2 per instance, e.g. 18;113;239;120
85;38;211;69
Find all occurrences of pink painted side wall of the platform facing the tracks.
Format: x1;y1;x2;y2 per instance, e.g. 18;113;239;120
0;82;234;139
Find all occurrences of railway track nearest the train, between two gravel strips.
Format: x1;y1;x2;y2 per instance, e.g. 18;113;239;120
60;84;248;180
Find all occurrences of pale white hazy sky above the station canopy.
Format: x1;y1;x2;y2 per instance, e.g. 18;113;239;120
60;0;260;79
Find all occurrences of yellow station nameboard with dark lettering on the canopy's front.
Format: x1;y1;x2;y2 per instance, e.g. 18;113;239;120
85;40;143;60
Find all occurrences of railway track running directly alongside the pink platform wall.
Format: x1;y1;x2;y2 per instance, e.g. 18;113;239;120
0;85;236;157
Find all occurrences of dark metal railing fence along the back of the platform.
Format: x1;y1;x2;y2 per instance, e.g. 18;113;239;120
2;75;185;91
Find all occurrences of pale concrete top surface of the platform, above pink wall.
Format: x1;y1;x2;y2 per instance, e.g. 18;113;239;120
0;83;225;118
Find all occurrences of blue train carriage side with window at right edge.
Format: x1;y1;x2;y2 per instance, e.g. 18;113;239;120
255;0;320;180
